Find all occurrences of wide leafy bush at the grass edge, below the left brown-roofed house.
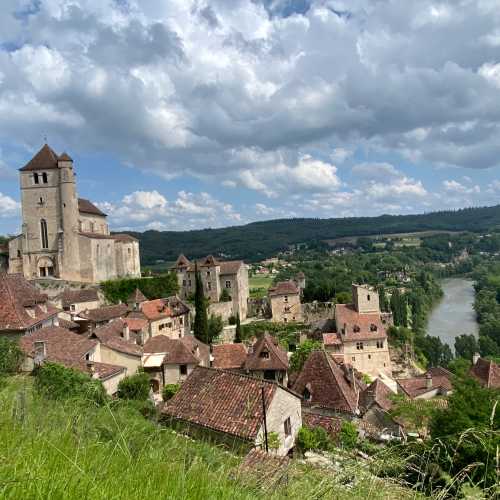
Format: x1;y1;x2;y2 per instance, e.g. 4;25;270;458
34;362;107;405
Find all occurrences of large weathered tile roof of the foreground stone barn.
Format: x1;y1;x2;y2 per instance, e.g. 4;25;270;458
162;366;284;441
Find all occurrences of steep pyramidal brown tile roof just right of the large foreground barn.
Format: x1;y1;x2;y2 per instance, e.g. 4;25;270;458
292;350;358;413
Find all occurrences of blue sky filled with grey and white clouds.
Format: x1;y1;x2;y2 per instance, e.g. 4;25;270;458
0;0;500;234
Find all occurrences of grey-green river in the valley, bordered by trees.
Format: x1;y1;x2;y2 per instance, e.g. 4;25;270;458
427;278;478;350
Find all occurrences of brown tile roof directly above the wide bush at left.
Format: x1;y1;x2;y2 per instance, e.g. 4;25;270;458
19;326;97;362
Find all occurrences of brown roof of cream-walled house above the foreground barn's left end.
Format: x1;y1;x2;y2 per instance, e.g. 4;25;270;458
144;335;209;365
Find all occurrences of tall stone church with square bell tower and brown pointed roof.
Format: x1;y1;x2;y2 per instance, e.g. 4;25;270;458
9;144;141;283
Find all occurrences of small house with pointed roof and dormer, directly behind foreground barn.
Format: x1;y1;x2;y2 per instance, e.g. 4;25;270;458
244;332;288;386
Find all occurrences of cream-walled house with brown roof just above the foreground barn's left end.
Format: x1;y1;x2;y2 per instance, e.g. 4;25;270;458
142;335;210;393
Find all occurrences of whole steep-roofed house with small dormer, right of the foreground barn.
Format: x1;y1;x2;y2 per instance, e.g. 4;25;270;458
292;350;366;418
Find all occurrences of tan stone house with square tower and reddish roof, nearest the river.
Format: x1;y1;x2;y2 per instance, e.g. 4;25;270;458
323;285;392;377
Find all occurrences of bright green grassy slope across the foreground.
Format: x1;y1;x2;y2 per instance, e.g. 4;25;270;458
0;377;417;500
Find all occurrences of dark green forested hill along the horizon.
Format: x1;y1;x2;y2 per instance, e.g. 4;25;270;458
129;205;500;265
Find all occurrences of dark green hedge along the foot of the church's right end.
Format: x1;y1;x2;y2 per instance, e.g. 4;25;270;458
101;272;179;304
